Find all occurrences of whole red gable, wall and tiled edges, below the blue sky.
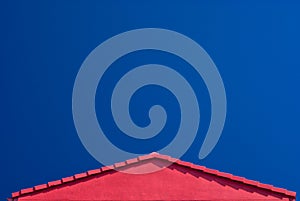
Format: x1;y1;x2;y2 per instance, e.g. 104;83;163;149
8;153;296;201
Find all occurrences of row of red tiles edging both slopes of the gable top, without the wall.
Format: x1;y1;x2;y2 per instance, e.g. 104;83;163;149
11;152;296;199
